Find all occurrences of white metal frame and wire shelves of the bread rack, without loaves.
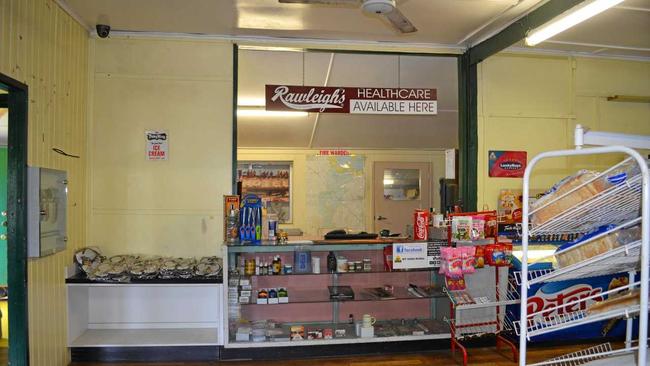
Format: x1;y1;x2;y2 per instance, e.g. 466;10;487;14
514;125;650;366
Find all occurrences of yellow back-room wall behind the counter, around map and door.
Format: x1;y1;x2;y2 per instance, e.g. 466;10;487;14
237;148;445;238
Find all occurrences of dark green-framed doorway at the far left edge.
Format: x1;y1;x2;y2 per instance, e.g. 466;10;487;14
0;74;29;365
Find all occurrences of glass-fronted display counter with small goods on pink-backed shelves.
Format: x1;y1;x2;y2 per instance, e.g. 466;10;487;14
224;240;450;348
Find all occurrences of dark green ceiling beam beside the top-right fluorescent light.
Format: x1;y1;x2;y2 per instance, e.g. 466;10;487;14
468;0;584;65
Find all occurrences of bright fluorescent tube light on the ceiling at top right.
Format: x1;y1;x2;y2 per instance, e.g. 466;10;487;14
526;0;623;46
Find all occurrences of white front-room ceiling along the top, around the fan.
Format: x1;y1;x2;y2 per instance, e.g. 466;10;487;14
57;0;650;58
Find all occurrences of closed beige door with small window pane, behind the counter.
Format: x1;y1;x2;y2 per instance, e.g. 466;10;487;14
373;161;433;236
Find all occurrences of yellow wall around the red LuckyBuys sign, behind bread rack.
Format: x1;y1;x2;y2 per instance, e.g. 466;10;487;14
477;54;650;208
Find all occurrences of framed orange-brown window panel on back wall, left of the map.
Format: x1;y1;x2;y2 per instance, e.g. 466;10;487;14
237;161;292;224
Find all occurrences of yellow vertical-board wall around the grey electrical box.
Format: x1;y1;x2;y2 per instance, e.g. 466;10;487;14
0;0;88;366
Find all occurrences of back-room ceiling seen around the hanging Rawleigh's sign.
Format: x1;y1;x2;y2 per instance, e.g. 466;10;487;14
237;50;458;149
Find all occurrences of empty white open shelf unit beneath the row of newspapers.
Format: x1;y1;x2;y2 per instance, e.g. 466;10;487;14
66;283;224;347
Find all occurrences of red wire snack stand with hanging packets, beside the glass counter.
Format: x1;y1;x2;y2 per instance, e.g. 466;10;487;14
442;211;520;365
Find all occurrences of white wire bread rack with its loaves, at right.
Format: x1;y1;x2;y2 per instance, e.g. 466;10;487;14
514;126;650;366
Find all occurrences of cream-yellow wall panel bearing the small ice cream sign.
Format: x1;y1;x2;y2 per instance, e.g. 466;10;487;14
89;37;233;256
